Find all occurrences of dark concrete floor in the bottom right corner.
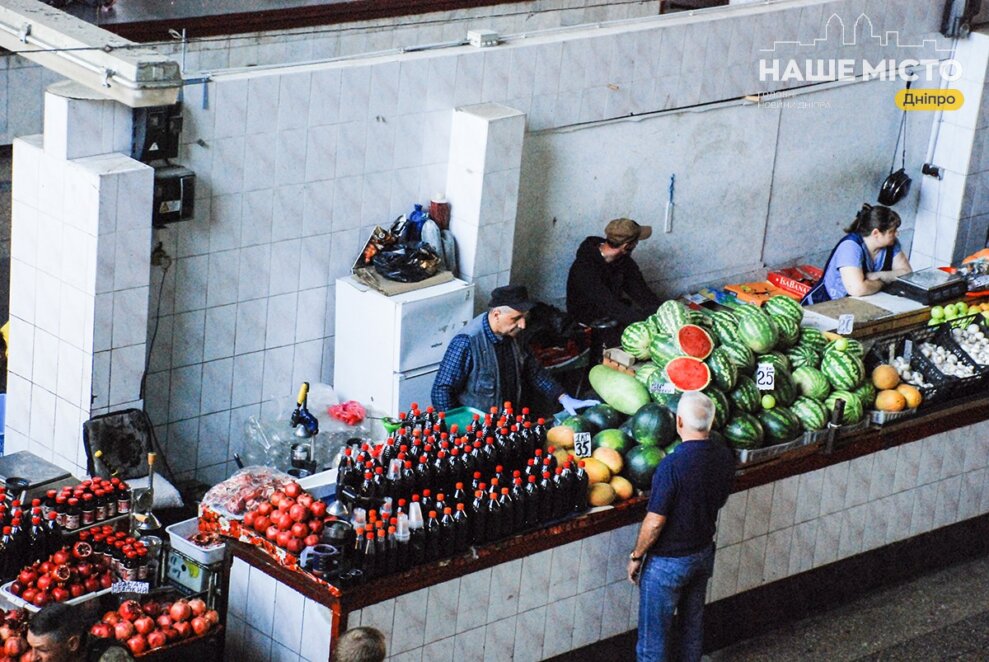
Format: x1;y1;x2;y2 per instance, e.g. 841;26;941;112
708;557;989;662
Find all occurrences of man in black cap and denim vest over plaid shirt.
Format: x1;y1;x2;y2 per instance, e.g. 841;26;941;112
431;285;597;413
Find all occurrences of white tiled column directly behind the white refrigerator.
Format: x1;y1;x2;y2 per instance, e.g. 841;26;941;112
446;103;525;311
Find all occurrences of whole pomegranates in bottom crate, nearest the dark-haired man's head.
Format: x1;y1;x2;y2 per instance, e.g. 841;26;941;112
89;598;220;656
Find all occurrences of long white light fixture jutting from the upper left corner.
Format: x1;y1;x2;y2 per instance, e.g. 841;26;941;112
0;0;182;108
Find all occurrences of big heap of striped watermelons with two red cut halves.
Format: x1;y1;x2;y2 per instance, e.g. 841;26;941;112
608;296;876;449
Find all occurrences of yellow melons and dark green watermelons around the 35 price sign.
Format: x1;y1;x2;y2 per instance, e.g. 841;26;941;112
546;402;680;506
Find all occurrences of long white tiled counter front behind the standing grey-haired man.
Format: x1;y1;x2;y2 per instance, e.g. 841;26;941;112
332;422;989;662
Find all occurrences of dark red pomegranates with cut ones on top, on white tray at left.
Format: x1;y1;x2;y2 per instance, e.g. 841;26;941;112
10;541;113;608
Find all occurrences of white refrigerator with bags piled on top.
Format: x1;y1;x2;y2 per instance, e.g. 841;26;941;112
333;276;474;416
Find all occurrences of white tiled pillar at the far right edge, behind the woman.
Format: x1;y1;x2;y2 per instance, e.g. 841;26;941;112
910;28;989;269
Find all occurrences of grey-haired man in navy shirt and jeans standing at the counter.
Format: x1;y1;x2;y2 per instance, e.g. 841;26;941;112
628;391;735;662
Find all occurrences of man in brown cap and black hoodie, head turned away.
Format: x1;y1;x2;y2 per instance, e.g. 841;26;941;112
567;218;661;334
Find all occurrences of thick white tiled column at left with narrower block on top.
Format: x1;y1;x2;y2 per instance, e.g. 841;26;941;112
6;84;154;475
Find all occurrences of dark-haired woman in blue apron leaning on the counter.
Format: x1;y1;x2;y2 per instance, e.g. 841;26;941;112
802;204;912;305
